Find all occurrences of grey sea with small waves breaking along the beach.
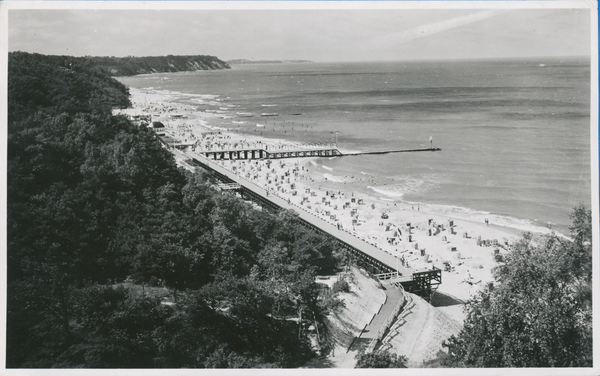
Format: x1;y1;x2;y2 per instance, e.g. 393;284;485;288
119;57;592;234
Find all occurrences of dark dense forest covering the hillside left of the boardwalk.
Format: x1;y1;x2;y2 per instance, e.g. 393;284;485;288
6;53;338;368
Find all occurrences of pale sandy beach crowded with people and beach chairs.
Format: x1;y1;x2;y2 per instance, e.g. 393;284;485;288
118;88;564;314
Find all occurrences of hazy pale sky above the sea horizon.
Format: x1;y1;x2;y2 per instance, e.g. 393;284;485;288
8;9;591;61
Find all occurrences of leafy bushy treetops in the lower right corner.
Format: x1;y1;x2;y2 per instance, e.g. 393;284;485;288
442;206;593;367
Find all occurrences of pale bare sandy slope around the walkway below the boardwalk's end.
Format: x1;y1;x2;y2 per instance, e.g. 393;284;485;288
303;269;461;368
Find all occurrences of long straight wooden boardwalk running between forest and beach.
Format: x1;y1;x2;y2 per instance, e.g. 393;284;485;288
186;151;441;294
